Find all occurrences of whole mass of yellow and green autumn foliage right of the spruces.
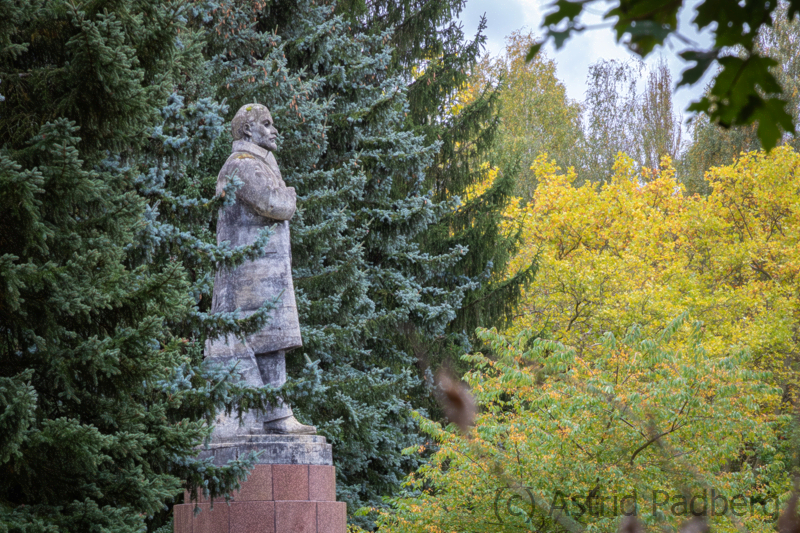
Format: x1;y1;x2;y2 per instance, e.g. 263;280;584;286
381;148;800;533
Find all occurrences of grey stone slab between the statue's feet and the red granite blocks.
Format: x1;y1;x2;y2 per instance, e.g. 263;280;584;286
199;430;333;465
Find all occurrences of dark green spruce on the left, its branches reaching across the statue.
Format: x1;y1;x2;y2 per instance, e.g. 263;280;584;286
0;0;288;532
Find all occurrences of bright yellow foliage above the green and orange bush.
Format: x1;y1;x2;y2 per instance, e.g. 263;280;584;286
509;147;800;388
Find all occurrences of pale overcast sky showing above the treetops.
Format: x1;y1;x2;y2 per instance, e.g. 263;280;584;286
461;0;710;124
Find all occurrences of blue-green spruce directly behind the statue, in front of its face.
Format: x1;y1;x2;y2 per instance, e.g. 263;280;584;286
183;0;464;526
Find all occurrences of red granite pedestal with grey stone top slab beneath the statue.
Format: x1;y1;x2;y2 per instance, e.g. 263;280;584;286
174;435;347;533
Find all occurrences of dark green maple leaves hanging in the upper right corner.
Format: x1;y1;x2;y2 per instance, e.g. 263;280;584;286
527;0;800;150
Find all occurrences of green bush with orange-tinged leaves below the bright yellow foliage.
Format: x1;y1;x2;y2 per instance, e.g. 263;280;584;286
381;314;791;533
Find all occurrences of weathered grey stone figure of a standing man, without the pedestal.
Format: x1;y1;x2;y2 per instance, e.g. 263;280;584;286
206;104;316;435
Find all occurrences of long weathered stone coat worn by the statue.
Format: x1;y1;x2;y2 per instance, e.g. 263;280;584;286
210;141;303;356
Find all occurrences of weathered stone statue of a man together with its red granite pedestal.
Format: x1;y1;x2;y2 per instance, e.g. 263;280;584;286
175;104;347;533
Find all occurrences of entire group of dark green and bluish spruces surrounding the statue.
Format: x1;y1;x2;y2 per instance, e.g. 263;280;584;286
0;0;529;532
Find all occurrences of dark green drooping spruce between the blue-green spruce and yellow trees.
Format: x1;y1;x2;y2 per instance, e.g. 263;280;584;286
339;0;535;371
